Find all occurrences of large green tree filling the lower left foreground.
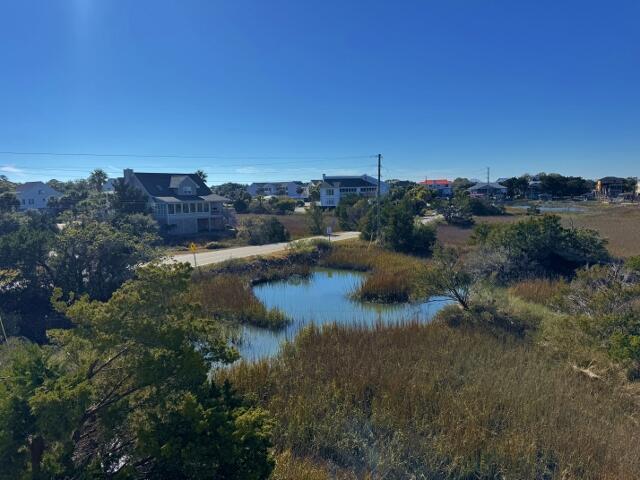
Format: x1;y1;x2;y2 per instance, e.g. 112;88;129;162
0;264;273;480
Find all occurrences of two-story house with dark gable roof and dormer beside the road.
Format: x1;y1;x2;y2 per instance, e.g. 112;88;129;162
124;169;235;235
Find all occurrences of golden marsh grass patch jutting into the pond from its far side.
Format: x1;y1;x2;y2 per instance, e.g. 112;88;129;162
322;241;426;303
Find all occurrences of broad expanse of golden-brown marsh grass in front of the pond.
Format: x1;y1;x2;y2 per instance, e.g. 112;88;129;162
224;321;640;479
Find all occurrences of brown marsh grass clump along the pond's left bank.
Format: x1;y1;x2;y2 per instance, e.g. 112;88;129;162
191;275;291;329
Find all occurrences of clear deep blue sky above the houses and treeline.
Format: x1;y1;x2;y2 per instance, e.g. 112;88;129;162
0;0;640;183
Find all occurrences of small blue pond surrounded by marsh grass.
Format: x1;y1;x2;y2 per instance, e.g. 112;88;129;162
238;268;447;360
